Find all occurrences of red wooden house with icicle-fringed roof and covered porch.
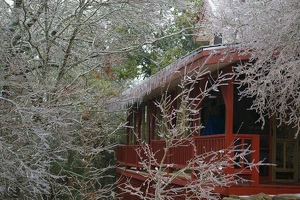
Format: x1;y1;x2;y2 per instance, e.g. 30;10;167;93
117;47;300;196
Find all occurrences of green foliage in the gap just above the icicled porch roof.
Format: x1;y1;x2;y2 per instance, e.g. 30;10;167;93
114;0;204;79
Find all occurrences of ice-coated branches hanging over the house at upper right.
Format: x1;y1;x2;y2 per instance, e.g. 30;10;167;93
208;0;300;137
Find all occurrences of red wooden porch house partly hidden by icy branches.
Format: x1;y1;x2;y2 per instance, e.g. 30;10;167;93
117;46;300;199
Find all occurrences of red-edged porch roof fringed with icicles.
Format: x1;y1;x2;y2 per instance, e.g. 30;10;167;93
118;45;248;108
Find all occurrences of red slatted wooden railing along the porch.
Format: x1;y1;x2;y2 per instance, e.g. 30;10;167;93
116;134;259;185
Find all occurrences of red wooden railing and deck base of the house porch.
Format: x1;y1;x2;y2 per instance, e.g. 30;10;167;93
117;134;300;196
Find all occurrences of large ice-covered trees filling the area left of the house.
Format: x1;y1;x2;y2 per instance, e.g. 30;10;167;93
0;0;196;199
